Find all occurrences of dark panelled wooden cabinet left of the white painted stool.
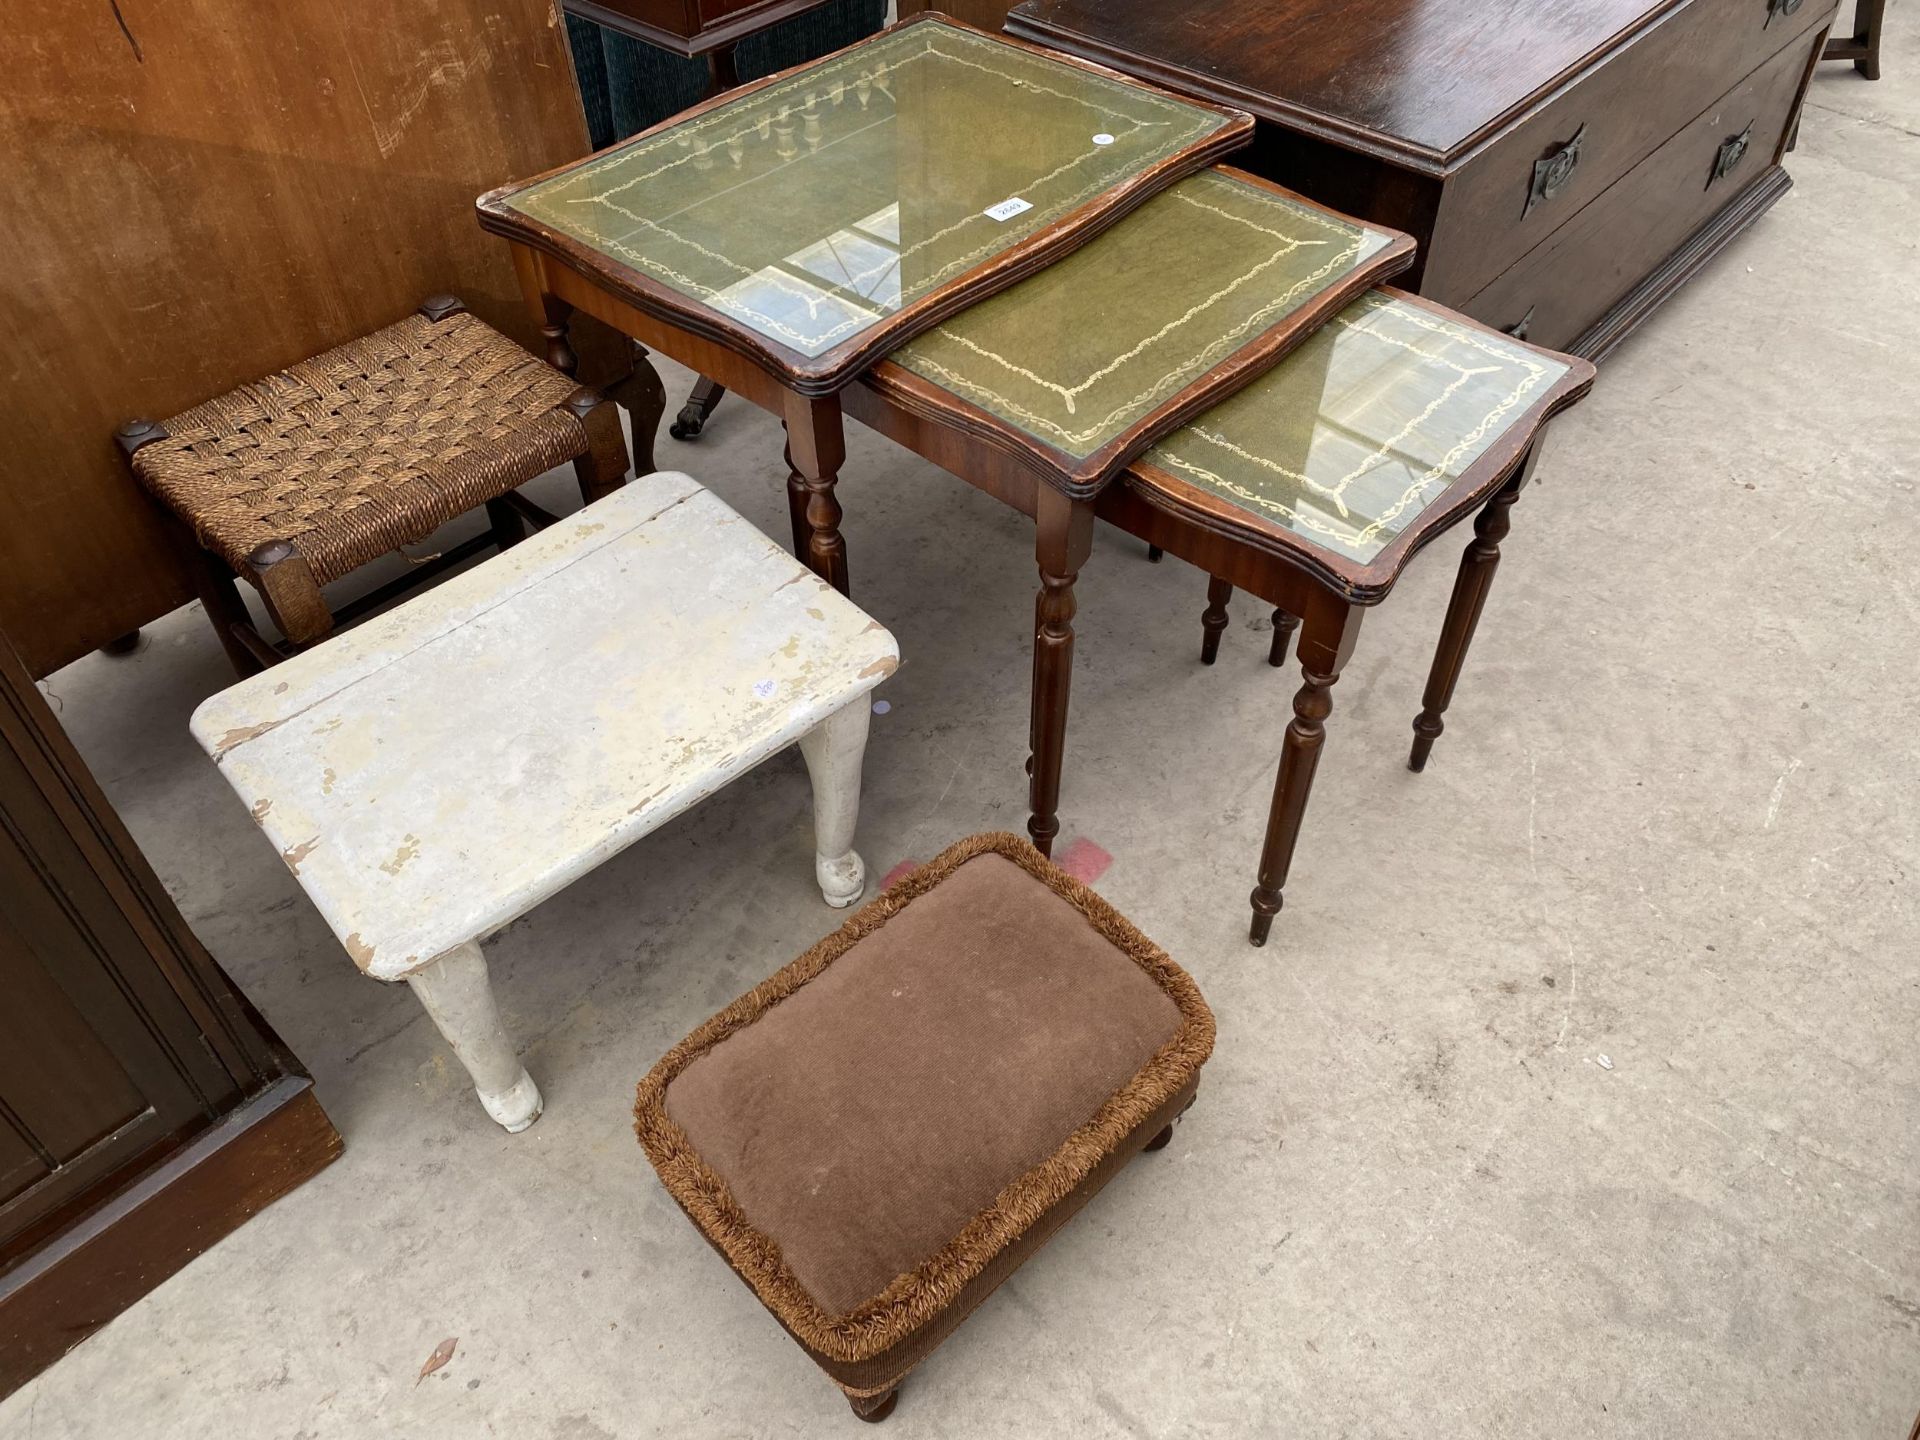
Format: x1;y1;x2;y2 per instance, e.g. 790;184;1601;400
0;636;340;1396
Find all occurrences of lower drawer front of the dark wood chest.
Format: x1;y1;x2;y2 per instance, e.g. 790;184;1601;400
1463;36;1818;349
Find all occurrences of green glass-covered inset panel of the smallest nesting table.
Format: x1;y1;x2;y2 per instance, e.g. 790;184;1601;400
1140;292;1567;563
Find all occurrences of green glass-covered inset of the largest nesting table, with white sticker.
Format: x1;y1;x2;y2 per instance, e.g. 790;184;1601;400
507;21;1227;355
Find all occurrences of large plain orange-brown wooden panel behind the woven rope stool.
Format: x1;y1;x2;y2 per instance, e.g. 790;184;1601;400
0;0;588;674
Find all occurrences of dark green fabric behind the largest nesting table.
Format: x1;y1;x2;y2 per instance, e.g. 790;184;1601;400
566;0;887;150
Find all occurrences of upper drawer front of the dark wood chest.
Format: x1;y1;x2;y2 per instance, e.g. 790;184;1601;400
1421;0;1834;305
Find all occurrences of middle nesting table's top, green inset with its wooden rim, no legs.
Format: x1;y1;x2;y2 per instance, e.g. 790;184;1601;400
868;167;1413;495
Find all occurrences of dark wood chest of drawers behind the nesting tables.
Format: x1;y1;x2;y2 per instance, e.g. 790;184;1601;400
1008;0;1836;357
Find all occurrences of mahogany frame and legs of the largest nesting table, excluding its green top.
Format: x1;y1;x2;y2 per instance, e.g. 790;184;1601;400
476;12;1254;593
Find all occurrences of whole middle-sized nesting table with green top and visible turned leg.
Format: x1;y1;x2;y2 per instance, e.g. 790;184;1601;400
845;167;1413;852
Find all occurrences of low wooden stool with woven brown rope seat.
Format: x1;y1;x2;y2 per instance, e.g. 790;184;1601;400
119;296;628;676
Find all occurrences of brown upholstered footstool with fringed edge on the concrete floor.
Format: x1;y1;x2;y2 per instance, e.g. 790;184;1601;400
636;835;1213;1421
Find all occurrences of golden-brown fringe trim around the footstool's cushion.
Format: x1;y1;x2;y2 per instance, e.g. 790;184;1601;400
634;831;1213;1363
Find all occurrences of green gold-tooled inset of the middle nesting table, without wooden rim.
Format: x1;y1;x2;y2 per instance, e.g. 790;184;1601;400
891;171;1388;457
